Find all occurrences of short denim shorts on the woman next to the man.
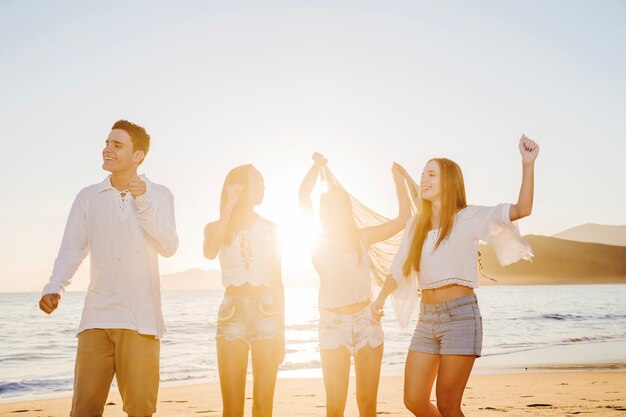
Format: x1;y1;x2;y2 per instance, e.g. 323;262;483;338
216;293;284;345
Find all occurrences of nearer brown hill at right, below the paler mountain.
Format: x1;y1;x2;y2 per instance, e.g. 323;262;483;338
480;235;626;285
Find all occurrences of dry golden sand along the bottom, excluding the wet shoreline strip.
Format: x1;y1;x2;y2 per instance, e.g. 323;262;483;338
0;372;626;417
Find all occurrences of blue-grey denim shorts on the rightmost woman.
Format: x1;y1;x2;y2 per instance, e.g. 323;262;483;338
409;294;483;357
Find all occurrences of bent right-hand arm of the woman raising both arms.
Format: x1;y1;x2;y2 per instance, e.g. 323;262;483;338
360;162;411;245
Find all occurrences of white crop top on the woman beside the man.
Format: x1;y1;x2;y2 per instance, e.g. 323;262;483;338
219;217;280;287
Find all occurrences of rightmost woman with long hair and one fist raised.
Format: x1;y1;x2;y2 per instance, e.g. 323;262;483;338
372;135;539;417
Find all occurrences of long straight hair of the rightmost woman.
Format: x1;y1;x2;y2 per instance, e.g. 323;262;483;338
402;158;467;276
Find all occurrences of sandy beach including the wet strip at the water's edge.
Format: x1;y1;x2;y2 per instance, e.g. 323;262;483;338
0;341;626;417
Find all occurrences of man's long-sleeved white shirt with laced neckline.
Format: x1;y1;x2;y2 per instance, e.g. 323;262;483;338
43;175;178;338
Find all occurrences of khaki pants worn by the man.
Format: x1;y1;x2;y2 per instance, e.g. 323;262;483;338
70;329;160;417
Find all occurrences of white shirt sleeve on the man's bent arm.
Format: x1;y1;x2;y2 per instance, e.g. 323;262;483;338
135;185;178;258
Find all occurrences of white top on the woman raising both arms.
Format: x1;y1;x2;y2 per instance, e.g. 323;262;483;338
312;240;372;308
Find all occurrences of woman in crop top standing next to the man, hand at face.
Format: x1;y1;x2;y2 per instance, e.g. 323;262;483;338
204;165;285;416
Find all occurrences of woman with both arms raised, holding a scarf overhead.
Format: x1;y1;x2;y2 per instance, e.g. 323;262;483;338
300;154;410;417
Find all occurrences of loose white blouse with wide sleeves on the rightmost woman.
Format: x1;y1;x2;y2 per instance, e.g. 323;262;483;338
390;204;533;327
